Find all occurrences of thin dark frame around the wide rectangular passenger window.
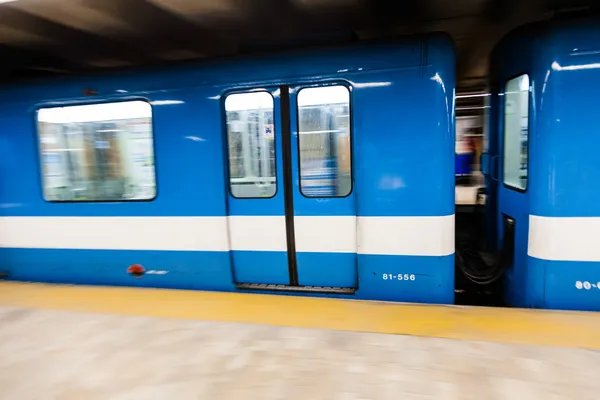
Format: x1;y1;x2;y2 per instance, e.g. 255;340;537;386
32;97;159;204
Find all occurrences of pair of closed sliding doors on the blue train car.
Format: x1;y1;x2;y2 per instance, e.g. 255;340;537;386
224;86;357;293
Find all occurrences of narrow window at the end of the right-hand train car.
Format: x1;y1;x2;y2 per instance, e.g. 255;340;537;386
503;75;529;190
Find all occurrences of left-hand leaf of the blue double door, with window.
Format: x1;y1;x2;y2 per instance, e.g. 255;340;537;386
224;88;290;287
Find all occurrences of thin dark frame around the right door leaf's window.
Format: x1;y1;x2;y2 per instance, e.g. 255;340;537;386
295;81;354;199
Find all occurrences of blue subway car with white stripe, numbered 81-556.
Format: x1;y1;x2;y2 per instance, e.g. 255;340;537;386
0;34;455;303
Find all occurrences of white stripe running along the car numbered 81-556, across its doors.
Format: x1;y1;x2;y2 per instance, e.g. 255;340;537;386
0;215;454;256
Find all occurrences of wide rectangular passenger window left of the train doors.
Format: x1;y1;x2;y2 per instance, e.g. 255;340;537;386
37;101;156;201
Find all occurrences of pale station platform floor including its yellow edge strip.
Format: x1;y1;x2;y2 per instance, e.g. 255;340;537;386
0;282;600;400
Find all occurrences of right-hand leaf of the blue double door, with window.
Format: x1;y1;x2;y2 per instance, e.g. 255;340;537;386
288;84;358;288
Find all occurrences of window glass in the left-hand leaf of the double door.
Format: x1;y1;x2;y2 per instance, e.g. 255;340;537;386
225;92;277;198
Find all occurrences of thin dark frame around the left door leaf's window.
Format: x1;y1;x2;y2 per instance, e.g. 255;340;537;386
221;87;279;200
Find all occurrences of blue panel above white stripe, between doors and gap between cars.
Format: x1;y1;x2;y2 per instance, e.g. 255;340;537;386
353;68;454;216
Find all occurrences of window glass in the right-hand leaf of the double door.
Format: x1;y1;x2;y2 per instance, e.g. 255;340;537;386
298;85;352;197
